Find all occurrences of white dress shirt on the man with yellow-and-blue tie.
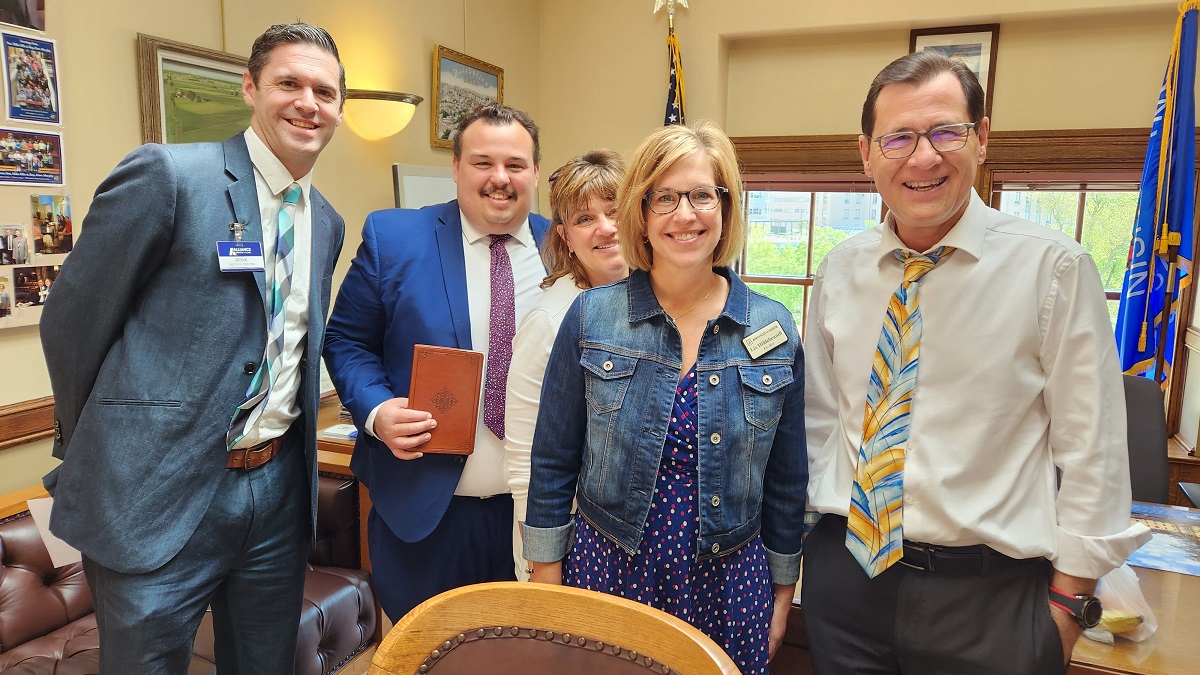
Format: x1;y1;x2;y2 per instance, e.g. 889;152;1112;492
804;192;1150;579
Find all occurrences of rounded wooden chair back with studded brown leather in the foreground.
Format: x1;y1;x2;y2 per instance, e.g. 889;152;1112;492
368;581;738;675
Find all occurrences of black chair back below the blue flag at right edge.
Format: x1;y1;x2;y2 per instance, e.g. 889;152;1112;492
1124;375;1170;504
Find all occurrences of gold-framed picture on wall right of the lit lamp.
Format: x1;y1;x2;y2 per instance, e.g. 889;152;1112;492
430;44;504;148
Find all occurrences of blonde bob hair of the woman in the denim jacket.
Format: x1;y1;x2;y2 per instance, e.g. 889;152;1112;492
617;120;746;270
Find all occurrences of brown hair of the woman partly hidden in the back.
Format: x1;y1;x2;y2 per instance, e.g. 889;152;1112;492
541;149;625;288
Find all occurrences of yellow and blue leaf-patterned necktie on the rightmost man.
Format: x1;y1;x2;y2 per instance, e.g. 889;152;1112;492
846;246;954;579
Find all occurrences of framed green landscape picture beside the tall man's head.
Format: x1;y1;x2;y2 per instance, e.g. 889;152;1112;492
138;32;250;143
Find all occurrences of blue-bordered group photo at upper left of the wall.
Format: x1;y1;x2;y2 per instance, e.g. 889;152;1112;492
2;32;62;124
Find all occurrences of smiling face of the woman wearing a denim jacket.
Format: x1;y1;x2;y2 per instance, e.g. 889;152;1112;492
643;153;722;275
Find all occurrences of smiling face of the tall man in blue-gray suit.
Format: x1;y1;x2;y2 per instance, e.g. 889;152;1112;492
241;43;342;178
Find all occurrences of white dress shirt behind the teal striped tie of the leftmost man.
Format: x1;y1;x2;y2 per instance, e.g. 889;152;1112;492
235;129;312;448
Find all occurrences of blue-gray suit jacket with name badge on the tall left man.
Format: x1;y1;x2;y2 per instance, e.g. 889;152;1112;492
41;133;346;573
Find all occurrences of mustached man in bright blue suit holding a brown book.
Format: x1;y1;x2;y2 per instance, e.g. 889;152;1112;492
325;104;550;620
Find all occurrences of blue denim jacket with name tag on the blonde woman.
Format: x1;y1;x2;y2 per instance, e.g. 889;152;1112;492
523;268;808;584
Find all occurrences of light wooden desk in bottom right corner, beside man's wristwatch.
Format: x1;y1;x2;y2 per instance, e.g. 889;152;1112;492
1070;567;1200;675
